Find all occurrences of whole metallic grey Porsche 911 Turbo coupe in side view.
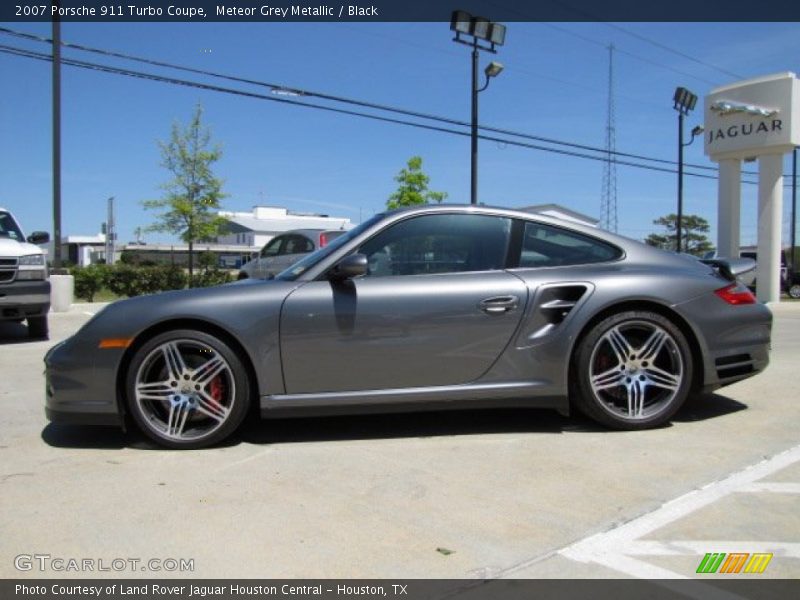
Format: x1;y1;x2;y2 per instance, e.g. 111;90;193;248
45;205;772;448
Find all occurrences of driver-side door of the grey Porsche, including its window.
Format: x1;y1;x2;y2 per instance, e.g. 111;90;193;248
280;213;528;394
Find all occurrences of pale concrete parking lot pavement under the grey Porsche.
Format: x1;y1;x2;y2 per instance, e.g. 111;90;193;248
0;303;800;578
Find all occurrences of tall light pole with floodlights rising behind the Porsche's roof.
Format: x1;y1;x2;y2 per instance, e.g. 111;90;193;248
450;10;506;204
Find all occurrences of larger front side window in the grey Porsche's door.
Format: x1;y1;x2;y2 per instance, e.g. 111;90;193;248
358;214;511;277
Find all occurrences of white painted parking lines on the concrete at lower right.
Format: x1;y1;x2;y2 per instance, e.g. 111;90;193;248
556;446;800;579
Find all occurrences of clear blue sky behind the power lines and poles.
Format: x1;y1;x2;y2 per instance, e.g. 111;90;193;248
0;23;800;243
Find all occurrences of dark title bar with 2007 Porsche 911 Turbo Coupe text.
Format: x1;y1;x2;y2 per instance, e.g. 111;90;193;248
0;0;800;23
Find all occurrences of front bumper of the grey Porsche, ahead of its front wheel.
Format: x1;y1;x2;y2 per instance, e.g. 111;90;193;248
44;337;124;427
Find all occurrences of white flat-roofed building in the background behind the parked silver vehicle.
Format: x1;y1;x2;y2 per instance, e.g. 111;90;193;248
217;206;353;249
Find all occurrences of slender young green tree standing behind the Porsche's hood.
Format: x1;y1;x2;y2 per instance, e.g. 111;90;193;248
143;104;225;286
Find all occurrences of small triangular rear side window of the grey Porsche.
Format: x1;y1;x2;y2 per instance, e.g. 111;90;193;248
519;221;622;267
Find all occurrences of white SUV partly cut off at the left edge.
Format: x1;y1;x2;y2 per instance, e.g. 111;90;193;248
0;207;50;338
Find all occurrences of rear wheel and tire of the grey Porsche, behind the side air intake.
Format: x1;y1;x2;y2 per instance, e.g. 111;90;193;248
572;311;693;430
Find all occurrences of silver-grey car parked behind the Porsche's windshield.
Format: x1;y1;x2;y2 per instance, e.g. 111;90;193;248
239;229;345;279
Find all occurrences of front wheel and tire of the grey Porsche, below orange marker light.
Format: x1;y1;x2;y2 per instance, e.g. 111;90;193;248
126;329;250;449
